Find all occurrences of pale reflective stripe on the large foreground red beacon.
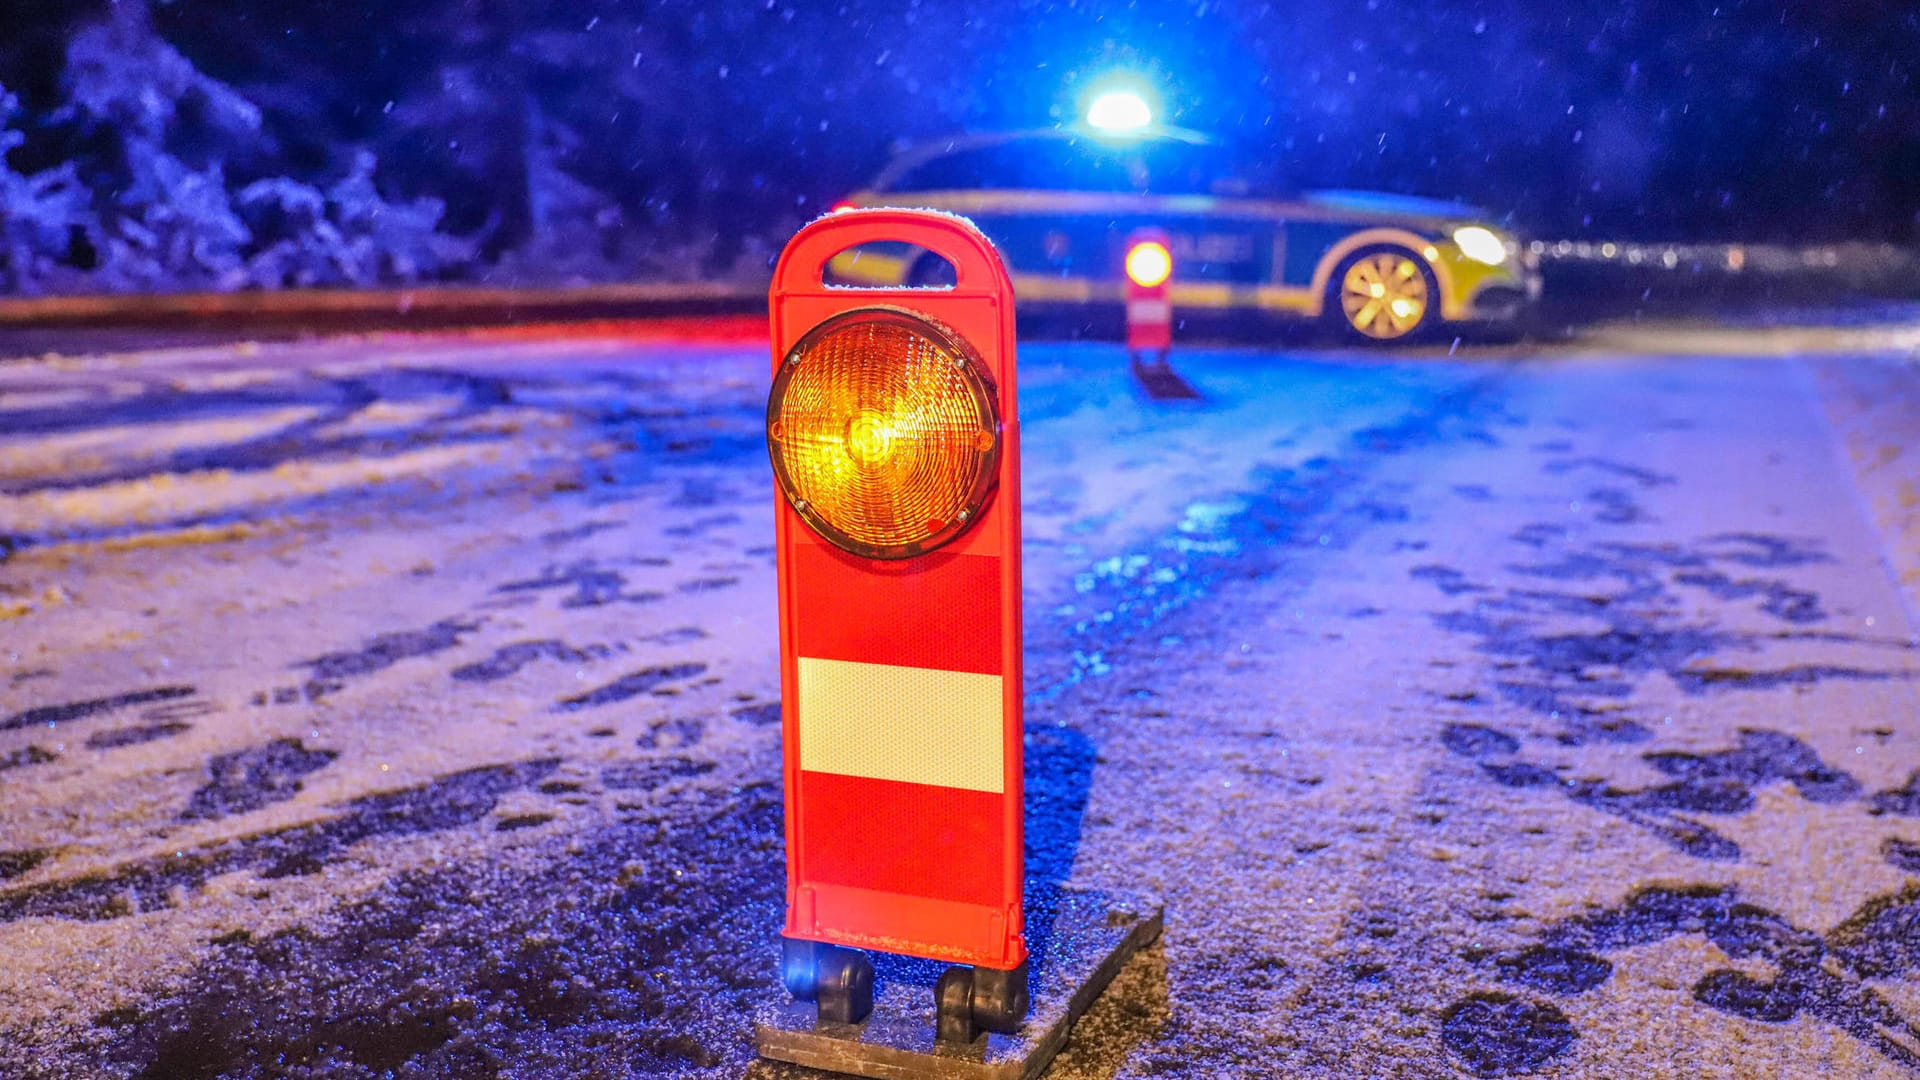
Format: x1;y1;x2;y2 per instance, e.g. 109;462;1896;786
799;657;1006;792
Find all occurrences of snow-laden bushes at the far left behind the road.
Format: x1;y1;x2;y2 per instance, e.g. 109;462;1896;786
0;2;474;294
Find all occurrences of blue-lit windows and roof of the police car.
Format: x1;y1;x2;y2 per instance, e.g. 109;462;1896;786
887;135;1271;194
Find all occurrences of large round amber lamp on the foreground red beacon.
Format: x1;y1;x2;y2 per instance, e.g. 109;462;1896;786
766;307;1000;559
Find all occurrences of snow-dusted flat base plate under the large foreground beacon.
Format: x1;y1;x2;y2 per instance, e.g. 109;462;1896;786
753;890;1162;1080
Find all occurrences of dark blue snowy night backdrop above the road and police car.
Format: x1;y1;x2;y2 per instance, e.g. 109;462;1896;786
0;0;1920;290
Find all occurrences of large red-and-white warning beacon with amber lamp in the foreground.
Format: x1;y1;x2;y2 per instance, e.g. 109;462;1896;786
766;209;1027;1042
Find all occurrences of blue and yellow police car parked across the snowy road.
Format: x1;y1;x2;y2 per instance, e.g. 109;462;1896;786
829;127;1540;342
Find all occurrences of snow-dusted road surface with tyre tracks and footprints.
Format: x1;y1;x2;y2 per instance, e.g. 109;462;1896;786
0;329;1920;1078
